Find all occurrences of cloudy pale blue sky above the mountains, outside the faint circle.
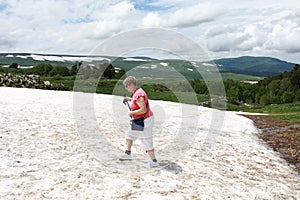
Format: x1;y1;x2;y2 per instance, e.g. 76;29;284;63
0;0;300;63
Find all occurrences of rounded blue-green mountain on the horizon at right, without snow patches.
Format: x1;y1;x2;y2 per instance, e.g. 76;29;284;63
214;56;295;77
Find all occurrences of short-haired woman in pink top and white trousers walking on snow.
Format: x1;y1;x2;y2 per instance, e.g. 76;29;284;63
120;76;159;167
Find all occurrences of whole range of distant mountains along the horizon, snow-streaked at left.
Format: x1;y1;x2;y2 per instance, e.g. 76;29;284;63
0;53;295;79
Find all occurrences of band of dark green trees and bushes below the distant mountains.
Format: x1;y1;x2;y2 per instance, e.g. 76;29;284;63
0;63;300;108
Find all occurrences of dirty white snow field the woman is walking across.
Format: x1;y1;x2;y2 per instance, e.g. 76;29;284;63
0;87;300;199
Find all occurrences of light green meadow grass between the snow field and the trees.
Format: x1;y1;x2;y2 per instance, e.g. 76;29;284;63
42;76;300;122
